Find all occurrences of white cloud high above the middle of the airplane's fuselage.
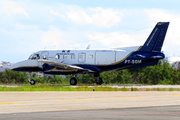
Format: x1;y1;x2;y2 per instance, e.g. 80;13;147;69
51;7;123;28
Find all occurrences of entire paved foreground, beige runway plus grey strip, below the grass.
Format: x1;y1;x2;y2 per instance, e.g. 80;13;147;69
0;91;180;120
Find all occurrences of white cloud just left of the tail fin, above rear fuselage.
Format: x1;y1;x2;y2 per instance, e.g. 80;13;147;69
87;32;148;48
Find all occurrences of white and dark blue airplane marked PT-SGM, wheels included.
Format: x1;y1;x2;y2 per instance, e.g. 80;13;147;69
11;22;169;85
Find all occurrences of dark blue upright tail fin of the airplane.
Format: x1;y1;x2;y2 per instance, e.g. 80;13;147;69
139;22;169;52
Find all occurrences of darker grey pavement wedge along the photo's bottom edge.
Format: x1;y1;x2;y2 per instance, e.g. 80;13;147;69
0;106;180;120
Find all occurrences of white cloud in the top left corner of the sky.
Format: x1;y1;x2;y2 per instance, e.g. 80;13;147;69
0;0;28;16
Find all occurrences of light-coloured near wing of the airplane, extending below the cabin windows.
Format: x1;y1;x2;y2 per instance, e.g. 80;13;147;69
38;59;83;70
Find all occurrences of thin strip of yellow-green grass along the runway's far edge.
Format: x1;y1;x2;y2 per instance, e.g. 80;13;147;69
0;85;180;92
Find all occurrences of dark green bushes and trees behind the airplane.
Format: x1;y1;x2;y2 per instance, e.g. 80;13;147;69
0;61;180;85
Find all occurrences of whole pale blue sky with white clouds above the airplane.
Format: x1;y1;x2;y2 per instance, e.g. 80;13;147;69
0;0;180;63
